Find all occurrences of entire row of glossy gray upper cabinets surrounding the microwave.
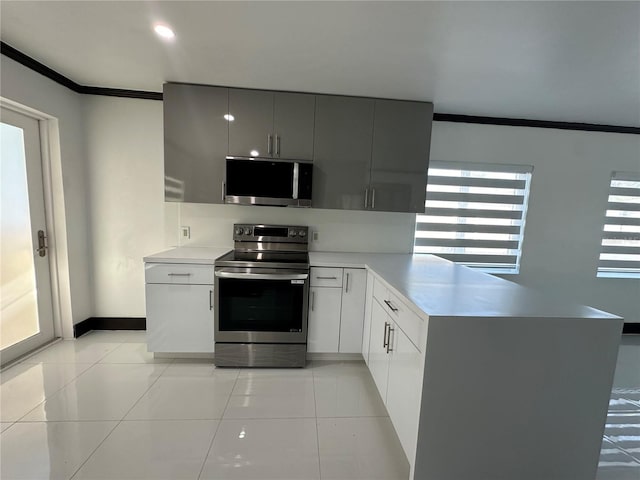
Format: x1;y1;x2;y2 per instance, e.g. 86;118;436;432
164;83;433;213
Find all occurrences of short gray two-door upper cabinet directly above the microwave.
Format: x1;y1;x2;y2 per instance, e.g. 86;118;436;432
229;89;315;160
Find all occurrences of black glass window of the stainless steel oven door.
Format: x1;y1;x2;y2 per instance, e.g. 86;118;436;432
218;278;305;332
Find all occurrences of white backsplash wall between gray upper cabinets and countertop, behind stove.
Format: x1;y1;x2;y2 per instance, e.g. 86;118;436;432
164;202;415;253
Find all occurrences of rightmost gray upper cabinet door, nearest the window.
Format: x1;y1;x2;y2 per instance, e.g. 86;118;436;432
370;100;433;213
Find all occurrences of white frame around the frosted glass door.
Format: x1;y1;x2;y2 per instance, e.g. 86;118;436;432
0;97;68;344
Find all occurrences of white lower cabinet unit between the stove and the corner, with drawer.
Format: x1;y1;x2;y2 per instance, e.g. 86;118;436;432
307;267;367;353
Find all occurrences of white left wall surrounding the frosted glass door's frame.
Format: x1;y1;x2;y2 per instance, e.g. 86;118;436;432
0;55;93;336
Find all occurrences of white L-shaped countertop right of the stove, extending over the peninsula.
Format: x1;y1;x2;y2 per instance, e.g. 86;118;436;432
309;252;620;320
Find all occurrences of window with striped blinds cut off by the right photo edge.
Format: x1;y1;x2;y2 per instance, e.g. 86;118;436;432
597;172;640;278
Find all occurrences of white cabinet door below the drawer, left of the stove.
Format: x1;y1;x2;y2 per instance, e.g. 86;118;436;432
145;284;214;352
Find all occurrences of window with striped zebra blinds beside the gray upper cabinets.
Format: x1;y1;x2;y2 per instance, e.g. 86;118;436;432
414;161;533;273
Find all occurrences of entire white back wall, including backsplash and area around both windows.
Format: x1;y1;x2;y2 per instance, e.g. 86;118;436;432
81;97;640;321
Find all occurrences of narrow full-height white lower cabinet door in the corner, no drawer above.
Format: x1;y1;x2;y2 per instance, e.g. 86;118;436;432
338;268;367;353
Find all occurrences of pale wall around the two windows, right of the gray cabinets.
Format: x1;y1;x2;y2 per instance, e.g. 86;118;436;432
431;122;640;322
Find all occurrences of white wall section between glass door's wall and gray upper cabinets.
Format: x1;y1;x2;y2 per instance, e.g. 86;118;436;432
84;95;167;317
